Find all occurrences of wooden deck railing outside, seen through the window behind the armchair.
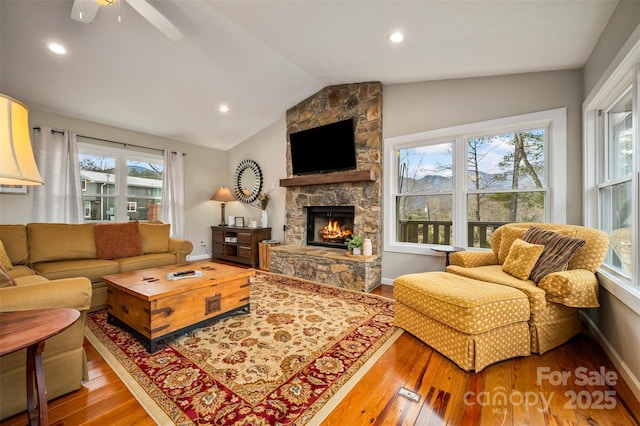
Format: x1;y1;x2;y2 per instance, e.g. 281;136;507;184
398;220;509;248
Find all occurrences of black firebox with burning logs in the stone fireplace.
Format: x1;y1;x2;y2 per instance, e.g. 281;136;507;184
307;206;354;248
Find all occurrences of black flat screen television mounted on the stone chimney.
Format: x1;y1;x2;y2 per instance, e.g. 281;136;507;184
289;118;356;175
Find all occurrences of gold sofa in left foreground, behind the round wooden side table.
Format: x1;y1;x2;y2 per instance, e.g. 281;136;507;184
0;274;91;419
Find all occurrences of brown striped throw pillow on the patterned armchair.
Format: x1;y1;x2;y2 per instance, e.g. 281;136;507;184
522;226;587;282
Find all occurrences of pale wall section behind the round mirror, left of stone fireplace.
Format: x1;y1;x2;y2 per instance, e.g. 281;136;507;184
226;119;287;243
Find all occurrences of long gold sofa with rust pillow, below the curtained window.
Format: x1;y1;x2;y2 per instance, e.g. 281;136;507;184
0;222;193;311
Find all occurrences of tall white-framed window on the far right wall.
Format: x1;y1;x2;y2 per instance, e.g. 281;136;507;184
582;49;640;306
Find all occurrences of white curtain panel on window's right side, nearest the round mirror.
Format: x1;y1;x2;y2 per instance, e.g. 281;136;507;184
162;150;186;239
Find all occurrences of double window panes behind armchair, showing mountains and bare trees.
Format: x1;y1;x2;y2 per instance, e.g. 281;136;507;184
397;129;546;247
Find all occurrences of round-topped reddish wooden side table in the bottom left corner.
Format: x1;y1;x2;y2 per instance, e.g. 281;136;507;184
0;308;80;425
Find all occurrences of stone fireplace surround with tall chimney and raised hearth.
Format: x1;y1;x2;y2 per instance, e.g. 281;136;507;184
271;82;382;291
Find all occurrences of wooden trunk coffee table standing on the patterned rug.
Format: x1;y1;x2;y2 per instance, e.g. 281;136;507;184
102;261;255;353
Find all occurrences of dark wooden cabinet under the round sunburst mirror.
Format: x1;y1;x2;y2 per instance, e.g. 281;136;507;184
211;226;271;268
